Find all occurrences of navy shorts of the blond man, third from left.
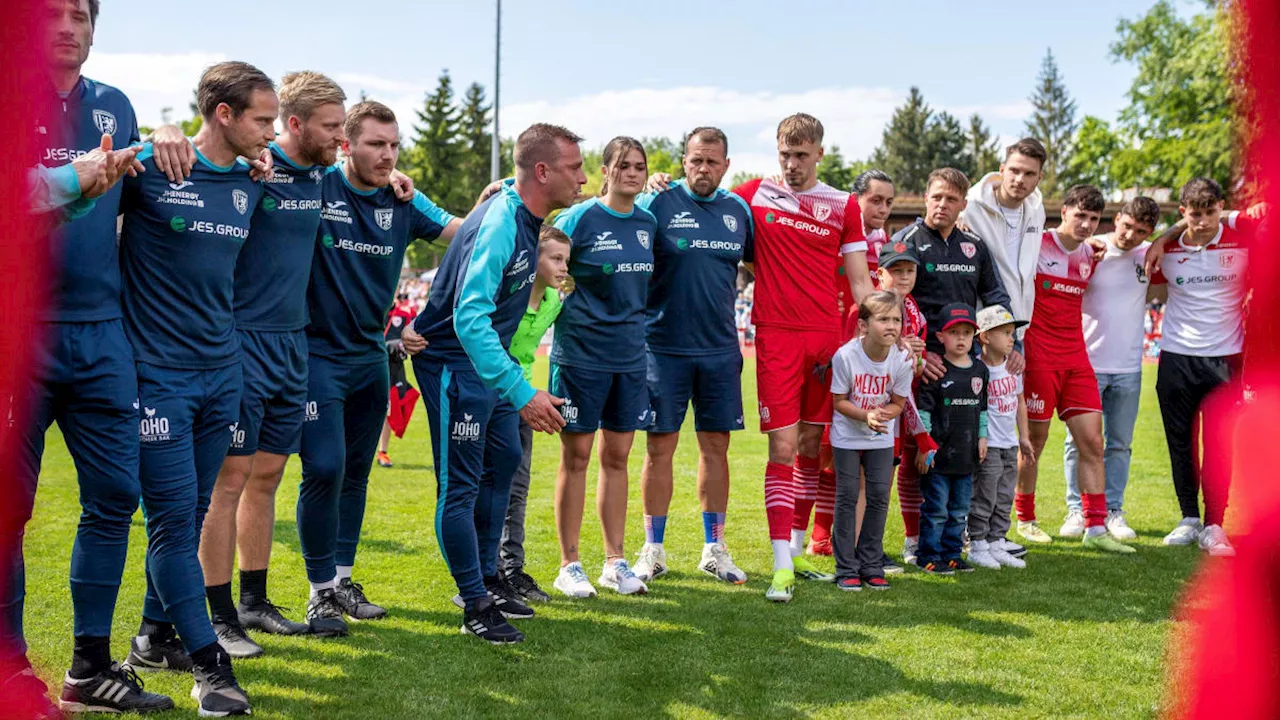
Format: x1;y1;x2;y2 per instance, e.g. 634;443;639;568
227;331;307;455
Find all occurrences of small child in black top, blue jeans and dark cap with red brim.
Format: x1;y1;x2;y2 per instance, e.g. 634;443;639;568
915;302;989;575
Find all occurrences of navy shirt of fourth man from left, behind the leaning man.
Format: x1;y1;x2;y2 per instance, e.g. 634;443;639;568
307;167;453;364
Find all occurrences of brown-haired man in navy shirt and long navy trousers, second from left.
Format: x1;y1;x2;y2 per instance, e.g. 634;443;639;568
120;61;279;715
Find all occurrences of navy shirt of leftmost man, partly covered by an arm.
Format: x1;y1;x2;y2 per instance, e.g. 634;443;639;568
36;77;138;323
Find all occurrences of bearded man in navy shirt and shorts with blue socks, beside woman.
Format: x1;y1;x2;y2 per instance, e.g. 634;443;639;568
635;127;754;584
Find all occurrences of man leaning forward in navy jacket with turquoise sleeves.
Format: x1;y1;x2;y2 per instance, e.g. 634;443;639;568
404;123;586;643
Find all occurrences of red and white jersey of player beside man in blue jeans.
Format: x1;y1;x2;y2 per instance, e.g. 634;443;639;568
1024;231;1097;370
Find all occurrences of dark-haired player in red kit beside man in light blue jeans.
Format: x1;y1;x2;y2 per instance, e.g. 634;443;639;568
1014;184;1135;552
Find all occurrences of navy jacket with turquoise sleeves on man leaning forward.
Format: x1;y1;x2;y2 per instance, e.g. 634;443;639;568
413;181;543;409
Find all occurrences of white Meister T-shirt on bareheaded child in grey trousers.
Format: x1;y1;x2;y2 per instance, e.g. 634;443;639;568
831;338;914;450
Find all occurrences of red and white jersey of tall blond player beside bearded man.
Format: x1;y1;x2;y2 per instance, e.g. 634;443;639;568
733;179;867;332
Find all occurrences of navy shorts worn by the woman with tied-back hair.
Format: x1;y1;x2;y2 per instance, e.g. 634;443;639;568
550;363;650;433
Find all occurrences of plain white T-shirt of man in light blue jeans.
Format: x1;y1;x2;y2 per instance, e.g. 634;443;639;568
1082;234;1151;374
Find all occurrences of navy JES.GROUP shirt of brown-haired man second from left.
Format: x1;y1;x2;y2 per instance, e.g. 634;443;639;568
120;143;262;369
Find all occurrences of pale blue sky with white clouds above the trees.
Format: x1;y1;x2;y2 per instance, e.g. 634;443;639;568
86;0;1177;173
